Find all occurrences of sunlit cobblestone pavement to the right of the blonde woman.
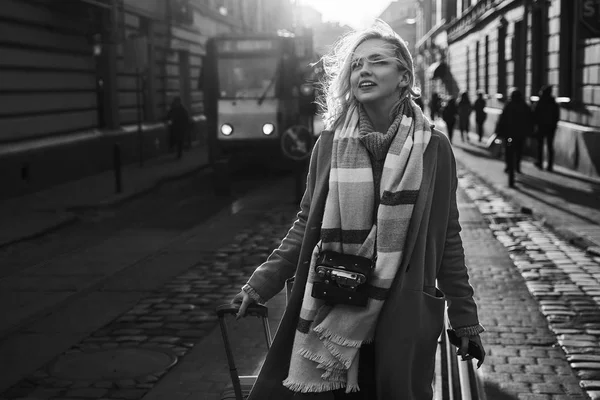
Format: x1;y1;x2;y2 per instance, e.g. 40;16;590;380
460;170;600;400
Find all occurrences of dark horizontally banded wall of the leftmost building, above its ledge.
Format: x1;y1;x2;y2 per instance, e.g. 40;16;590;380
0;0;99;143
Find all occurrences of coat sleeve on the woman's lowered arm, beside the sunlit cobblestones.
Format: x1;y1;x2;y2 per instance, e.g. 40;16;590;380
437;141;483;334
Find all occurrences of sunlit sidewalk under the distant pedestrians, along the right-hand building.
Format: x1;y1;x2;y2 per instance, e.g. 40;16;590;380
446;125;600;255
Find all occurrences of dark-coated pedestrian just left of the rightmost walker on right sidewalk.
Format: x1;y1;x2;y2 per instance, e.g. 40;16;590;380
496;89;533;173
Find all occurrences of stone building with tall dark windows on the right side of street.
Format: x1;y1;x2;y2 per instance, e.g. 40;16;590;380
417;0;600;178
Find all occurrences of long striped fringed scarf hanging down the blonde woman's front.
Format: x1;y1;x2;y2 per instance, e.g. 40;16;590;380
283;97;431;392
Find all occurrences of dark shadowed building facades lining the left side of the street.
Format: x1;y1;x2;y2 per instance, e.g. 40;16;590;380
0;0;292;197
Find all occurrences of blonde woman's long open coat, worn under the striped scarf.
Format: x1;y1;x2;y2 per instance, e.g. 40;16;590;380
248;131;479;400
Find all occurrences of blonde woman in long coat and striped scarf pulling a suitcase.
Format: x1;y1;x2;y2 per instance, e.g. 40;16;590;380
233;21;483;400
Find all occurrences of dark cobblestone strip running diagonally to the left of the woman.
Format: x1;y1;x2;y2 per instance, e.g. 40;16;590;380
0;206;294;400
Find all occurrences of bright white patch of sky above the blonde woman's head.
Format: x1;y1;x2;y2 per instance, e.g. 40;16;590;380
296;0;392;29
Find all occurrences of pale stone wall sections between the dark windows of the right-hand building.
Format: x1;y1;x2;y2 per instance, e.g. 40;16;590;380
448;0;600;178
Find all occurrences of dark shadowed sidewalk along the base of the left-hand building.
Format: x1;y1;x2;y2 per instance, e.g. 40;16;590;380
0;147;208;248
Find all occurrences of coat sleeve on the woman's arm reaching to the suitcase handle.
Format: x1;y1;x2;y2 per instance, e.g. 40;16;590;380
244;139;321;302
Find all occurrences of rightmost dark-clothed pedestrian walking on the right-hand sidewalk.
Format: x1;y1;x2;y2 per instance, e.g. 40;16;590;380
534;85;560;171
